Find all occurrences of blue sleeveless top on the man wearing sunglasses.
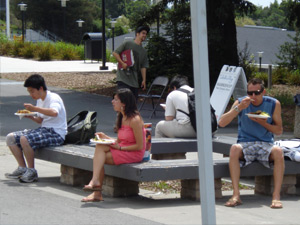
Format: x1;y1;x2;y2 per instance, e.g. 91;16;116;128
238;96;276;143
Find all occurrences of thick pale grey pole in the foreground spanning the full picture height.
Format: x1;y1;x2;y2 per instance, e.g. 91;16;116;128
190;0;216;225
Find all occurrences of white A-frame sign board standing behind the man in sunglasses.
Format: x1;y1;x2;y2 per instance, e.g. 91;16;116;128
210;65;247;121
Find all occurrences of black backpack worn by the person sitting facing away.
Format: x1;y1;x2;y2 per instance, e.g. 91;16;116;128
177;88;218;134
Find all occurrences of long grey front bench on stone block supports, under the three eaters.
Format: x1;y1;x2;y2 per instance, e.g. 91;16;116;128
35;139;300;200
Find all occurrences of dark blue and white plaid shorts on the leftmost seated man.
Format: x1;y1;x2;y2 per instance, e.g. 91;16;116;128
14;127;64;150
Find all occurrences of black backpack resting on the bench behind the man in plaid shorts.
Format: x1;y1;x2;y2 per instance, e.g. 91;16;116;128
65;110;98;144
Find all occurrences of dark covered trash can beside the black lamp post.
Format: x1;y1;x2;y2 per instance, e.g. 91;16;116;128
82;33;102;62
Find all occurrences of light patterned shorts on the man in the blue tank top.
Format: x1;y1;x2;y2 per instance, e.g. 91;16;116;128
238;141;274;168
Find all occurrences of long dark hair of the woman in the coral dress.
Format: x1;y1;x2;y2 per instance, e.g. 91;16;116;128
113;88;140;130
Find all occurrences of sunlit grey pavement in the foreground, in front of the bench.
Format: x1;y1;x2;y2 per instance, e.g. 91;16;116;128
0;142;300;225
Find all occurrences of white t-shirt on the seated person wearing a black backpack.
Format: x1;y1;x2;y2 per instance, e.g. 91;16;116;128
165;85;194;124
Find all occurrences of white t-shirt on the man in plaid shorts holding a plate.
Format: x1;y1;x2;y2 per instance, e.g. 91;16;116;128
36;91;67;139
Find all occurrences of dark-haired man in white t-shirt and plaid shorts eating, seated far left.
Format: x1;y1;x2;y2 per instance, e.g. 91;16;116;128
5;74;67;183
